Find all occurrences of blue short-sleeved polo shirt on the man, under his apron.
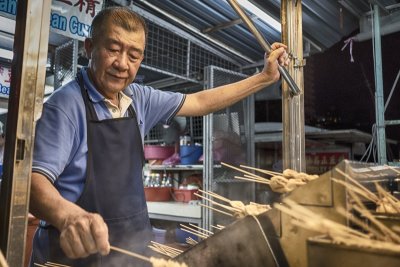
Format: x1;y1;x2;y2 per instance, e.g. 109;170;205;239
32;69;185;202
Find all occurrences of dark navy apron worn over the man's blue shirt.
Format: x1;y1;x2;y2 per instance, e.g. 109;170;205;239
31;75;152;267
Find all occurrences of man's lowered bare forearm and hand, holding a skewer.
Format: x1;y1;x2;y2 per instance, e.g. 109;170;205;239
29;172;110;259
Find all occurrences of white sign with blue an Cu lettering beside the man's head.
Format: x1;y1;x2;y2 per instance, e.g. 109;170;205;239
50;0;103;40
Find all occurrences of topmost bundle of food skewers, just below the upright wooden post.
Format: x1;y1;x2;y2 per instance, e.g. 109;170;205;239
221;162;319;193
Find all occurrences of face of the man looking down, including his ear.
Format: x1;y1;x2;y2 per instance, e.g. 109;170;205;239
85;24;145;99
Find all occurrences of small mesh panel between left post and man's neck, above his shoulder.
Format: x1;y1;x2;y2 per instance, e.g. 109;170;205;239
54;40;78;90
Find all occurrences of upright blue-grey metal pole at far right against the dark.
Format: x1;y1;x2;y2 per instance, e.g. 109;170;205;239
373;4;387;164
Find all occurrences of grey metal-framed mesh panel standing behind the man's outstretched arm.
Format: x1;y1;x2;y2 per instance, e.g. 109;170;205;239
202;66;255;230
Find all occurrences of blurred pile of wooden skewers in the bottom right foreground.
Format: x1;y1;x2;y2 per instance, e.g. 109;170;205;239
274;168;400;253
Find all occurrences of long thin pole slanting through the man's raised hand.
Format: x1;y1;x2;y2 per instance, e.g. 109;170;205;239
228;0;301;95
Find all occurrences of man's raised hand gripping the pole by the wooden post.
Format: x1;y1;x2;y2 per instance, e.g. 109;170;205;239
263;43;289;82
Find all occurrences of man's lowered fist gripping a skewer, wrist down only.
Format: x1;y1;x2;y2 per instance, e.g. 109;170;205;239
60;212;110;259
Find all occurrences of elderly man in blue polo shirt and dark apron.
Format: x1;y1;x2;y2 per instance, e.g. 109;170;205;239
30;7;287;267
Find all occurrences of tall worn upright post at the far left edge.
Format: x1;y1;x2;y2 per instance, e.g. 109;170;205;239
0;0;51;266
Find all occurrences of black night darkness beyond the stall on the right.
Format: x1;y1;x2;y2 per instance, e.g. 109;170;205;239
256;32;400;140
